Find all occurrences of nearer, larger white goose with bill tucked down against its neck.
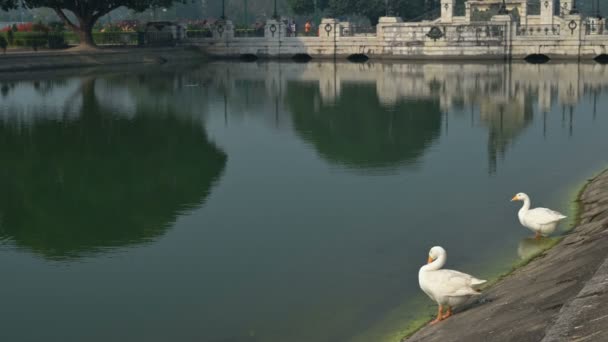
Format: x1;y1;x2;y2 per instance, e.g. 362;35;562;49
418;246;486;324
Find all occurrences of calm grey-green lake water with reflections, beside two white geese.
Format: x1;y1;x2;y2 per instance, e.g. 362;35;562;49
0;62;608;342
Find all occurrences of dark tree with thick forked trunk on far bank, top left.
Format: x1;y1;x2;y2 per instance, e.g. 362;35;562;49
0;0;185;47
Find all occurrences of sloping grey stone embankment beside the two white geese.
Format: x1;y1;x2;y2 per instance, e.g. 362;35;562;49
404;170;608;342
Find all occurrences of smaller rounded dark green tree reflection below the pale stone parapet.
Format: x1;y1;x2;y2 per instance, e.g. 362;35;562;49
285;82;441;169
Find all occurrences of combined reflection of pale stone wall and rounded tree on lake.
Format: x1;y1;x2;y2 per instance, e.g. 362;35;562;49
194;62;608;173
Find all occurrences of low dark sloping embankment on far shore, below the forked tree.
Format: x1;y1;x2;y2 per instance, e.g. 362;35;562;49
0;47;205;72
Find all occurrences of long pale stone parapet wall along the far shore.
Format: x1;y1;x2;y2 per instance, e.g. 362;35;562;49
195;15;608;60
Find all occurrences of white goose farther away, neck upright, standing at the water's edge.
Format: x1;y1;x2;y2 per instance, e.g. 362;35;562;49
511;192;566;239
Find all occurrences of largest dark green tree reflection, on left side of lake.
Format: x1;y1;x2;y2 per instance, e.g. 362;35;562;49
0;78;226;259
